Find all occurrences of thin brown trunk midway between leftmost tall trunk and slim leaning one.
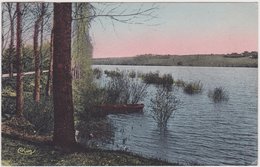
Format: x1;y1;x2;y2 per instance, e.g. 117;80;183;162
33;20;41;103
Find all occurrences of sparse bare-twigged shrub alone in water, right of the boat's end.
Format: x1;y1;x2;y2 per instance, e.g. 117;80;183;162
150;86;180;128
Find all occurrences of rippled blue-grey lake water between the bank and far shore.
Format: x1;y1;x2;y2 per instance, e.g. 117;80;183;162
86;65;258;165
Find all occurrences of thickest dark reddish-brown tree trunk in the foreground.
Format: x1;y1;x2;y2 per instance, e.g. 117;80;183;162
53;3;76;148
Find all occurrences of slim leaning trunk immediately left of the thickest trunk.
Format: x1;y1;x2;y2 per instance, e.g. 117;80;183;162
45;29;53;97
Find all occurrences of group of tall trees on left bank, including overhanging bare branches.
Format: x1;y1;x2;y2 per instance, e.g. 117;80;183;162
2;2;156;147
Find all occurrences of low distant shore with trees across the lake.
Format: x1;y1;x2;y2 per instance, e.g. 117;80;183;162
93;51;258;67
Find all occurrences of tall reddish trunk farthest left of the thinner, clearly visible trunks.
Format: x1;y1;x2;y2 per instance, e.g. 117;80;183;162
16;3;24;117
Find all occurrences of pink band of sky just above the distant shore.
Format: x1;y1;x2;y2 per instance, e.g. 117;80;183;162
94;30;258;57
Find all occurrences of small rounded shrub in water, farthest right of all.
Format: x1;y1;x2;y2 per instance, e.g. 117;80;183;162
208;87;229;103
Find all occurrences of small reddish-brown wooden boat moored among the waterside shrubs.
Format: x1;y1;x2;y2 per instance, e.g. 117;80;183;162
96;104;144;115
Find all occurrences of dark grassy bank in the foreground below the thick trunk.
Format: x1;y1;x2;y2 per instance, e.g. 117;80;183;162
2;135;174;166
